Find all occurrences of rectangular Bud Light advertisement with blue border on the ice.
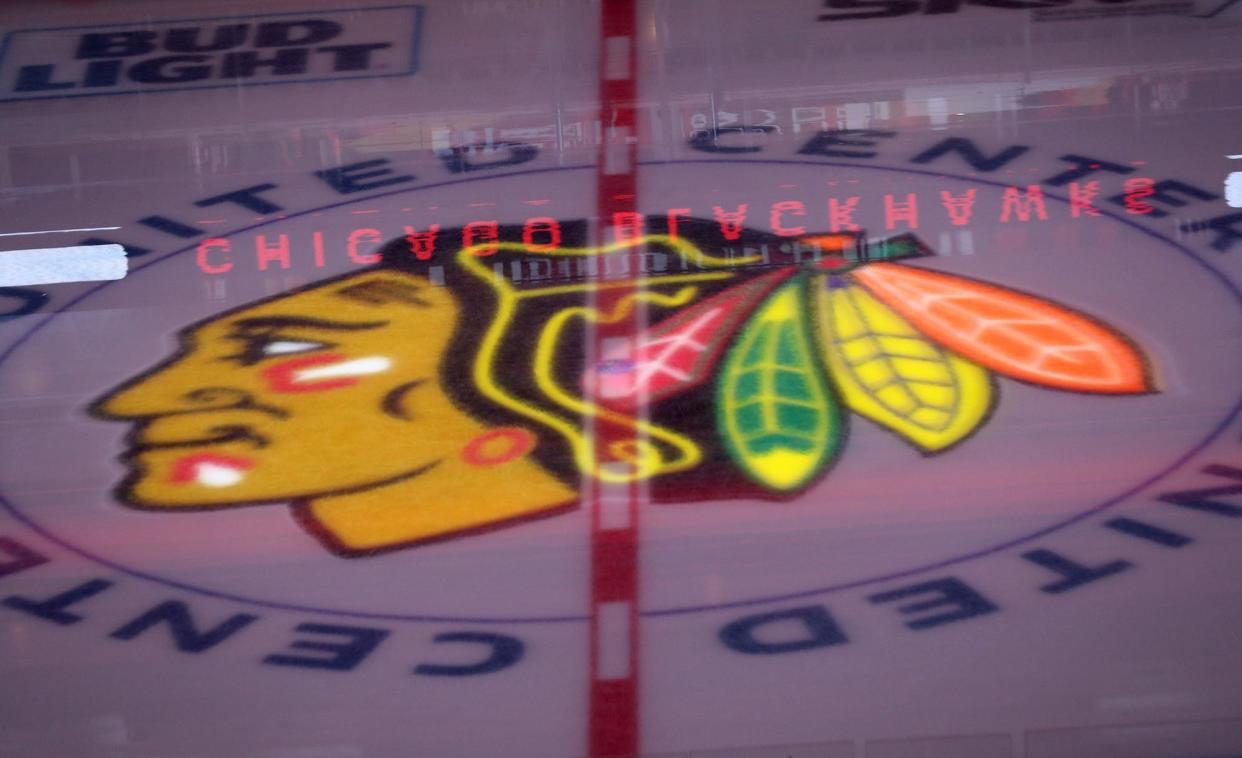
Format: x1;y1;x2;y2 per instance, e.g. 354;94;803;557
0;5;422;102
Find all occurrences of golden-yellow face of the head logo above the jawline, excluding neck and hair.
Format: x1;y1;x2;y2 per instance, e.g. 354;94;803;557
98;268;465;507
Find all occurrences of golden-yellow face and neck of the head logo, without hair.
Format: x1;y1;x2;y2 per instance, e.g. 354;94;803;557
94;270;569;552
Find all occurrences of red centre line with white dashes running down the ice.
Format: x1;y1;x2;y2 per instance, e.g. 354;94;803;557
584;0;641;758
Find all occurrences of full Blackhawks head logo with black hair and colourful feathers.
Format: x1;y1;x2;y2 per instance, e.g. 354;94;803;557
92;220;1153;555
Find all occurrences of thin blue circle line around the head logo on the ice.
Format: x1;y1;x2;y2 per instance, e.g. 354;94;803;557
0;158;1242;624
